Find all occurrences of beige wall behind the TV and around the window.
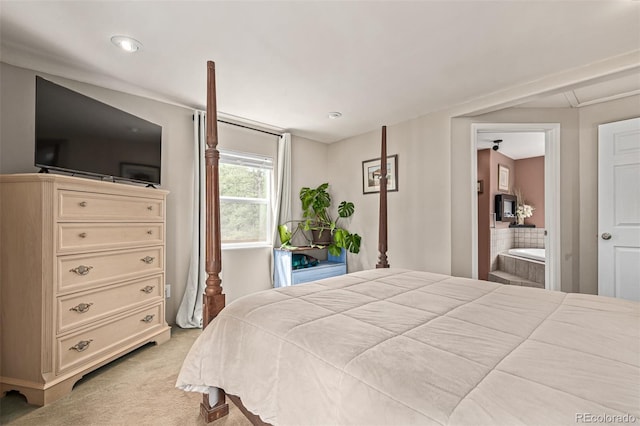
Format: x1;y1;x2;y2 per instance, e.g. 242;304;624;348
0;63;328;323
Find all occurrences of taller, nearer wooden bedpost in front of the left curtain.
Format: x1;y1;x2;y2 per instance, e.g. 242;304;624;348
200;61;229;423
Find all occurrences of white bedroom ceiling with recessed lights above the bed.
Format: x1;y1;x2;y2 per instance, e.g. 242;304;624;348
0;0;640;142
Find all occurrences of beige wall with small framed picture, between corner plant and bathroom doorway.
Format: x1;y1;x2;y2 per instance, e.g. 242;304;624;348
328;114;452;274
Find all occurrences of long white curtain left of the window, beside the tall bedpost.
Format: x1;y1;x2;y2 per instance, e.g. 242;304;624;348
176;111;207;328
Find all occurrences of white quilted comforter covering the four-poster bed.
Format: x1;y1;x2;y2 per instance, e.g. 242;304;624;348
177;269;640;426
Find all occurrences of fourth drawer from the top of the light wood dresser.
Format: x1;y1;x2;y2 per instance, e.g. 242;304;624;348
57;275;164;333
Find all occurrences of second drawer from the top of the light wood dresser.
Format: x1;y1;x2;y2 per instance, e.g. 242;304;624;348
58;222;164;253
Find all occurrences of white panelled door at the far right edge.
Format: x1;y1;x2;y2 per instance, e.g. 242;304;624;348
598;118;640;301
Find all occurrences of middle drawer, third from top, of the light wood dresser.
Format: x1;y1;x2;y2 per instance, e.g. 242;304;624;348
57;246;164;292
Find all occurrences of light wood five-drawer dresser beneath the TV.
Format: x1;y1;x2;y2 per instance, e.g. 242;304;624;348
0;173;170;405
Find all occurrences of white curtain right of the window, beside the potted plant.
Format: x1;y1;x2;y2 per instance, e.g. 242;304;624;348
271;133;291;285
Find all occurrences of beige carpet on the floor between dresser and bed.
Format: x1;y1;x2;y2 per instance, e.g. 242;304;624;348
0;327;251;426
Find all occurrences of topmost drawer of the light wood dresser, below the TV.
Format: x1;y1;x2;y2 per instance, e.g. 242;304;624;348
58;190;164;220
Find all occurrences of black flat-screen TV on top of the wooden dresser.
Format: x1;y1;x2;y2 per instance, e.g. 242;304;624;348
35;77;162;185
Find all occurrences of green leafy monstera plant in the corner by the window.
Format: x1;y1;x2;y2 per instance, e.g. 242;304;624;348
278;183;361;256
